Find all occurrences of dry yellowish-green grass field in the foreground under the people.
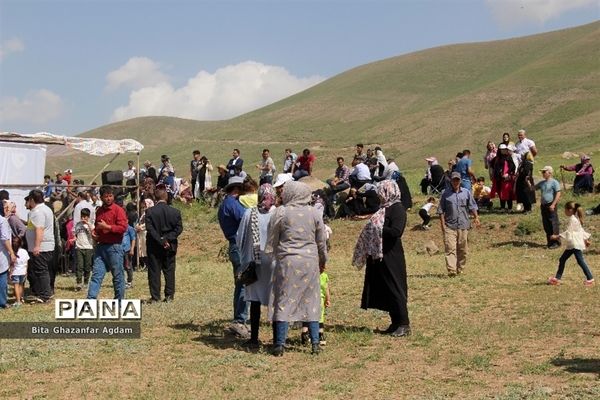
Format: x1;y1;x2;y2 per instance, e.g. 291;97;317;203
0;186;600;400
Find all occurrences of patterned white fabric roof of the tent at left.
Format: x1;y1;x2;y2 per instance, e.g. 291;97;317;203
0;132;144;156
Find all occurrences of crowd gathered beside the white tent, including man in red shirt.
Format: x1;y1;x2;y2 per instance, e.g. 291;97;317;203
0;152;183;308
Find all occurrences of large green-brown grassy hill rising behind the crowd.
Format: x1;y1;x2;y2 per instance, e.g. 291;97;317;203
49;22;600;177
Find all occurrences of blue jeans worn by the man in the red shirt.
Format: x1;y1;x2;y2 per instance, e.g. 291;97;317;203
87;243;125;300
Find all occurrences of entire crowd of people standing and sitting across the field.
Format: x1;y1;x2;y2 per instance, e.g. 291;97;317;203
0;130;600;356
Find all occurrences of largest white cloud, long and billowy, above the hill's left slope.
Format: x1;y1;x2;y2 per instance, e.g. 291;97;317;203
112;61;324;121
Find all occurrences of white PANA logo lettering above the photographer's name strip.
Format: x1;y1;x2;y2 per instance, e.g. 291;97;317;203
54;299;142;320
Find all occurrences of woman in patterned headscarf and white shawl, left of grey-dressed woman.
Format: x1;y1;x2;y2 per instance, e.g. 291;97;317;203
236;183;275;347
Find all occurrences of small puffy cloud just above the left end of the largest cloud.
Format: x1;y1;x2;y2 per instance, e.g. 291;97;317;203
106;57;169;90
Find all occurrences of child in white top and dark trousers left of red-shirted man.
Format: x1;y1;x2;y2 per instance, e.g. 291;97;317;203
73;208;94;291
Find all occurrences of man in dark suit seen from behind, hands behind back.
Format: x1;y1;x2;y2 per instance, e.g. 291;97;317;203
146;189;183;303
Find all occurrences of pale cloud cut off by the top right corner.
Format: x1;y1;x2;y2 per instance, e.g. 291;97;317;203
486;0;598;27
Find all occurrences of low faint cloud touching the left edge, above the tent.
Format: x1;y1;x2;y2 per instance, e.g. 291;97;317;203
0;89;64;124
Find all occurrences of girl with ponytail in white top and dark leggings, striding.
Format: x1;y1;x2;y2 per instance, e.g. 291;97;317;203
548;201;594;286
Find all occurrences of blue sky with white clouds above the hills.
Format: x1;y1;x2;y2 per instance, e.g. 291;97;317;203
0;0;600;135
